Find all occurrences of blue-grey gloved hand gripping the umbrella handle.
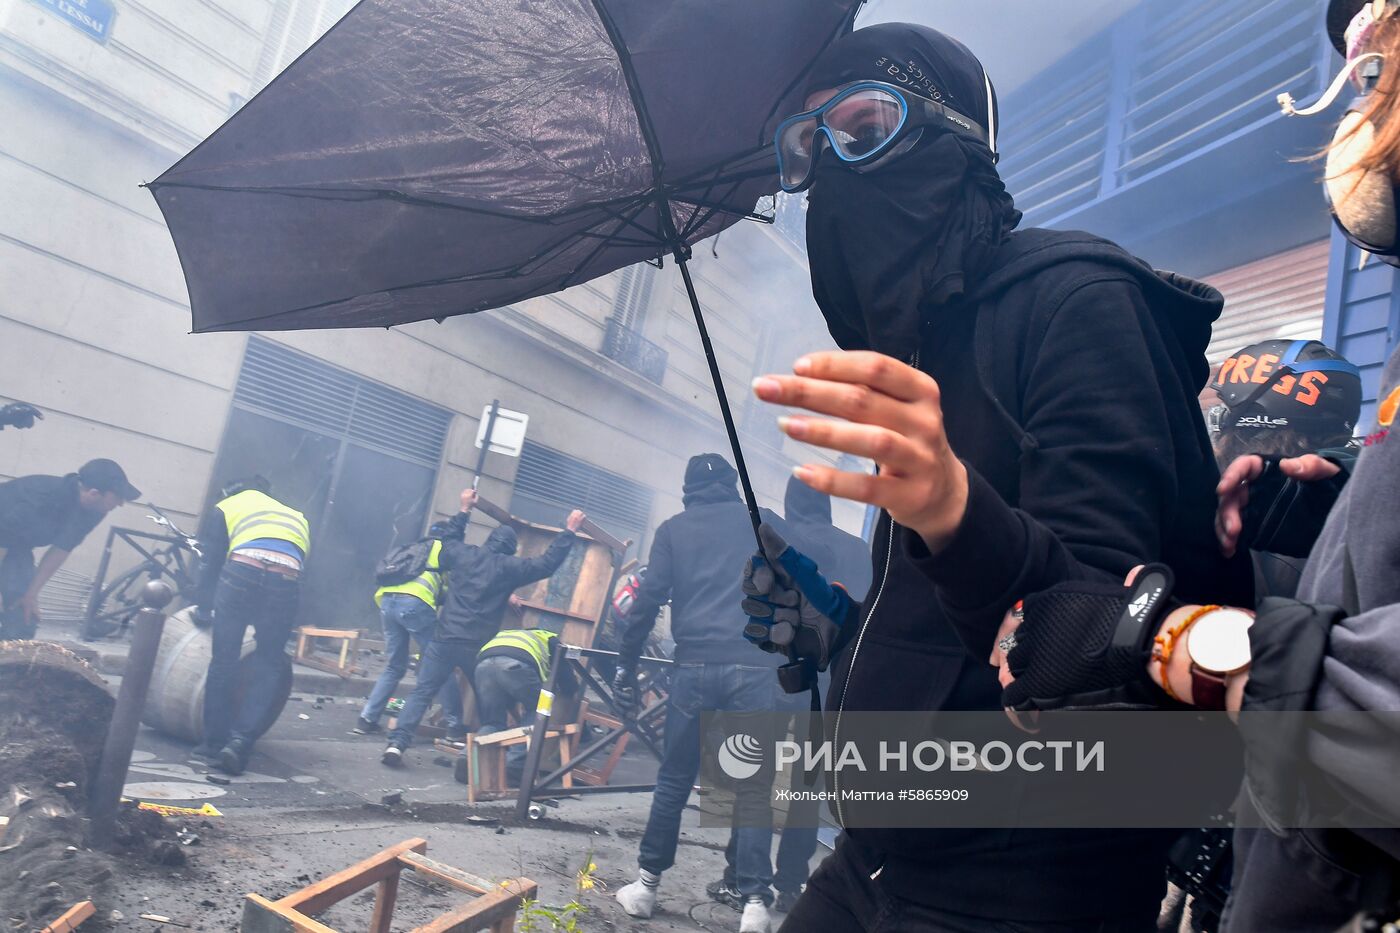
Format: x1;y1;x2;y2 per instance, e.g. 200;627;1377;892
743;524;855;671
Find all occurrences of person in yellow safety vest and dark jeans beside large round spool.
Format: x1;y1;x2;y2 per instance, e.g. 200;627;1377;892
193;476;311;775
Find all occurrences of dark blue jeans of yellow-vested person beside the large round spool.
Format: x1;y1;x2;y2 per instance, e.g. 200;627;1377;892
204;563;300;748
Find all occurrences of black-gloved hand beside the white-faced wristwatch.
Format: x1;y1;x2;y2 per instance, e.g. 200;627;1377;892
1001;563;1175;710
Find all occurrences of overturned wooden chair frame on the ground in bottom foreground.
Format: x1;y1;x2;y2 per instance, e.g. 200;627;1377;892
238;839;536;933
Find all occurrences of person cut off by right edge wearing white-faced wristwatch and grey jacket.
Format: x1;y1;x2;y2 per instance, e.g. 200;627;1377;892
994;0;1400;933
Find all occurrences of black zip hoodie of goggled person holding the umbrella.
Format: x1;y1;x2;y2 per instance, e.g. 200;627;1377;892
827;230;1252;920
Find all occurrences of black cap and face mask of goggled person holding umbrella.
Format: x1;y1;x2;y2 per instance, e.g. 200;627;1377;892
806;24;1021;360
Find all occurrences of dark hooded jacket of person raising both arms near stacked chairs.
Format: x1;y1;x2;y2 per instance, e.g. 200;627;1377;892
433;511;574;643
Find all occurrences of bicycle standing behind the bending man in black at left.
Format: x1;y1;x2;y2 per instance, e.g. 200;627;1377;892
83;503;203;642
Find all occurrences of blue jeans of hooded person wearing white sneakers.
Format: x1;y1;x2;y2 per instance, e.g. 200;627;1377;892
637;664;777;899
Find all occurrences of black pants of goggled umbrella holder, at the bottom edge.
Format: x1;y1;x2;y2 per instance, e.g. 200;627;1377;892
778;835;1156;933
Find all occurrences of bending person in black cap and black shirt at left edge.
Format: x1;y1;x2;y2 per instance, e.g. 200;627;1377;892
0;459;141;639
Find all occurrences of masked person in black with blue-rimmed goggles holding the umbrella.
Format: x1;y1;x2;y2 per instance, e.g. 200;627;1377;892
745;24;1252;932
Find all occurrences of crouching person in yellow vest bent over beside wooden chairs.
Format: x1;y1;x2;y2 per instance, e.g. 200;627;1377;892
473;629;578;785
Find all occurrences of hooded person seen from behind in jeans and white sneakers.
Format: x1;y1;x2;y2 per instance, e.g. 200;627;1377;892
613;454;778;933
